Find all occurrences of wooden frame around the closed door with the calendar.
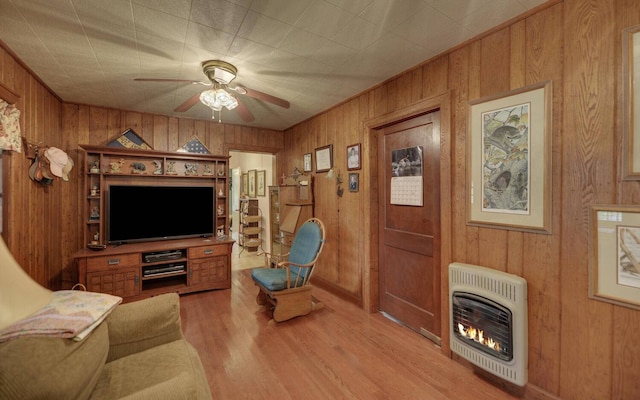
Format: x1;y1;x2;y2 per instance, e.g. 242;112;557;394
361;91;452;354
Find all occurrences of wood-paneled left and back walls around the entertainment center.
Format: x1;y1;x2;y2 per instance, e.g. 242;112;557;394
0;47;284;289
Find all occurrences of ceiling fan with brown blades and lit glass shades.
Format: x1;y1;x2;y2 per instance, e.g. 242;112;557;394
134;60;290;122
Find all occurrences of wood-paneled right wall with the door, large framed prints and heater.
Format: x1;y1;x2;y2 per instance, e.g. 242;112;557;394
284;0;640;400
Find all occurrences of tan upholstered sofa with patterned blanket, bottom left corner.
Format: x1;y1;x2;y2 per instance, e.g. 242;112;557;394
0;234;211;400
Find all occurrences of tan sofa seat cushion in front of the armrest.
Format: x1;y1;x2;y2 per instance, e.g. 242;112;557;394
91;340;211;399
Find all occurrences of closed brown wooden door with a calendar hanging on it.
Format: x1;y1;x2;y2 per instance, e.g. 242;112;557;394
378;111;441;342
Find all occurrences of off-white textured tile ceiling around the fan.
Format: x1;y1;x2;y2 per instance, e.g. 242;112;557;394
0;0;546;129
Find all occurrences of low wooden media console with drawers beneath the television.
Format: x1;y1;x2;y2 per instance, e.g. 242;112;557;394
74;238;234;301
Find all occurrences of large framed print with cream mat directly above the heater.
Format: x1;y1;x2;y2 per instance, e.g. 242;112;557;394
467;81;552;234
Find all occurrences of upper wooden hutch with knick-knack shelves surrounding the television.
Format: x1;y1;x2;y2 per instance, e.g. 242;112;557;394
80;145;230;245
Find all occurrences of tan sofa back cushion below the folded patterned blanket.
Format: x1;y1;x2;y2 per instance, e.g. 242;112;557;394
0;324;109;400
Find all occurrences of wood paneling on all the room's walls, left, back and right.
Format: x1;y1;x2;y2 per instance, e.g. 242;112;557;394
0;0;640;400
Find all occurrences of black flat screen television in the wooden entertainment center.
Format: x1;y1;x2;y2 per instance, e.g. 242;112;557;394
107;185;216;243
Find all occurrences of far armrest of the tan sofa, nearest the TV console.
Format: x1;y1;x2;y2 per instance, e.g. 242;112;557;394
105;293;184;362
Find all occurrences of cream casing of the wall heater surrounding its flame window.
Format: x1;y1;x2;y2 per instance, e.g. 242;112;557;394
449;263;528;386
